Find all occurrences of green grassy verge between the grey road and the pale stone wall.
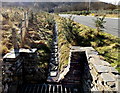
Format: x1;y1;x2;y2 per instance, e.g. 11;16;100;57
57;17;120;72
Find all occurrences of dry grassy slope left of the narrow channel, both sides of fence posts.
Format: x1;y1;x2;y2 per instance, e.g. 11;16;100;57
0;8;54;68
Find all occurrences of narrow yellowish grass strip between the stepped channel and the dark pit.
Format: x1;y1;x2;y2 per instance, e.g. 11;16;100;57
56;16;71;70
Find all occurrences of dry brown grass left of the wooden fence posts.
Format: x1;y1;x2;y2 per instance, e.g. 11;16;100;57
0;8;22;55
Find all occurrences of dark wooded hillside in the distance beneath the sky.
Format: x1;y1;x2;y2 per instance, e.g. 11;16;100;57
2;2;117;12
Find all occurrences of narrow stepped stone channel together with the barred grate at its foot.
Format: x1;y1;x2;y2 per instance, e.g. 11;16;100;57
17;24;61;93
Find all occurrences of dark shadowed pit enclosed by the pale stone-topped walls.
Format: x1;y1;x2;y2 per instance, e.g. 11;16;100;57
61;51;89;93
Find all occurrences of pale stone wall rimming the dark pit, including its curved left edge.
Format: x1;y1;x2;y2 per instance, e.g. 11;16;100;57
59;46;120;92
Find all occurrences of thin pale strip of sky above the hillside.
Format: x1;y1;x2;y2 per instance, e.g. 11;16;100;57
0;0;120;4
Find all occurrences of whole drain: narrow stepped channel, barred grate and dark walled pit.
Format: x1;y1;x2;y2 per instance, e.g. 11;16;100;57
4;20;92;93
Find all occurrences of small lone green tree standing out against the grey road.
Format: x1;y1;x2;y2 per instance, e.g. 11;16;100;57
94;15;106;32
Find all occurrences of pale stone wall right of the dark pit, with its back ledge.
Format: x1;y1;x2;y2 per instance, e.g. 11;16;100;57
71;47;119;91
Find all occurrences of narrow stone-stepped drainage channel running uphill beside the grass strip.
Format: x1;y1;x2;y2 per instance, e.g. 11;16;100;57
47;23;59;83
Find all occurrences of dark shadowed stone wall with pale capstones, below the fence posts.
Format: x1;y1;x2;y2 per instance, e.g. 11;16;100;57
0;48;37;93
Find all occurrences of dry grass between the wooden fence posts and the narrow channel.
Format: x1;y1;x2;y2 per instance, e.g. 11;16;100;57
28;12;54;70
